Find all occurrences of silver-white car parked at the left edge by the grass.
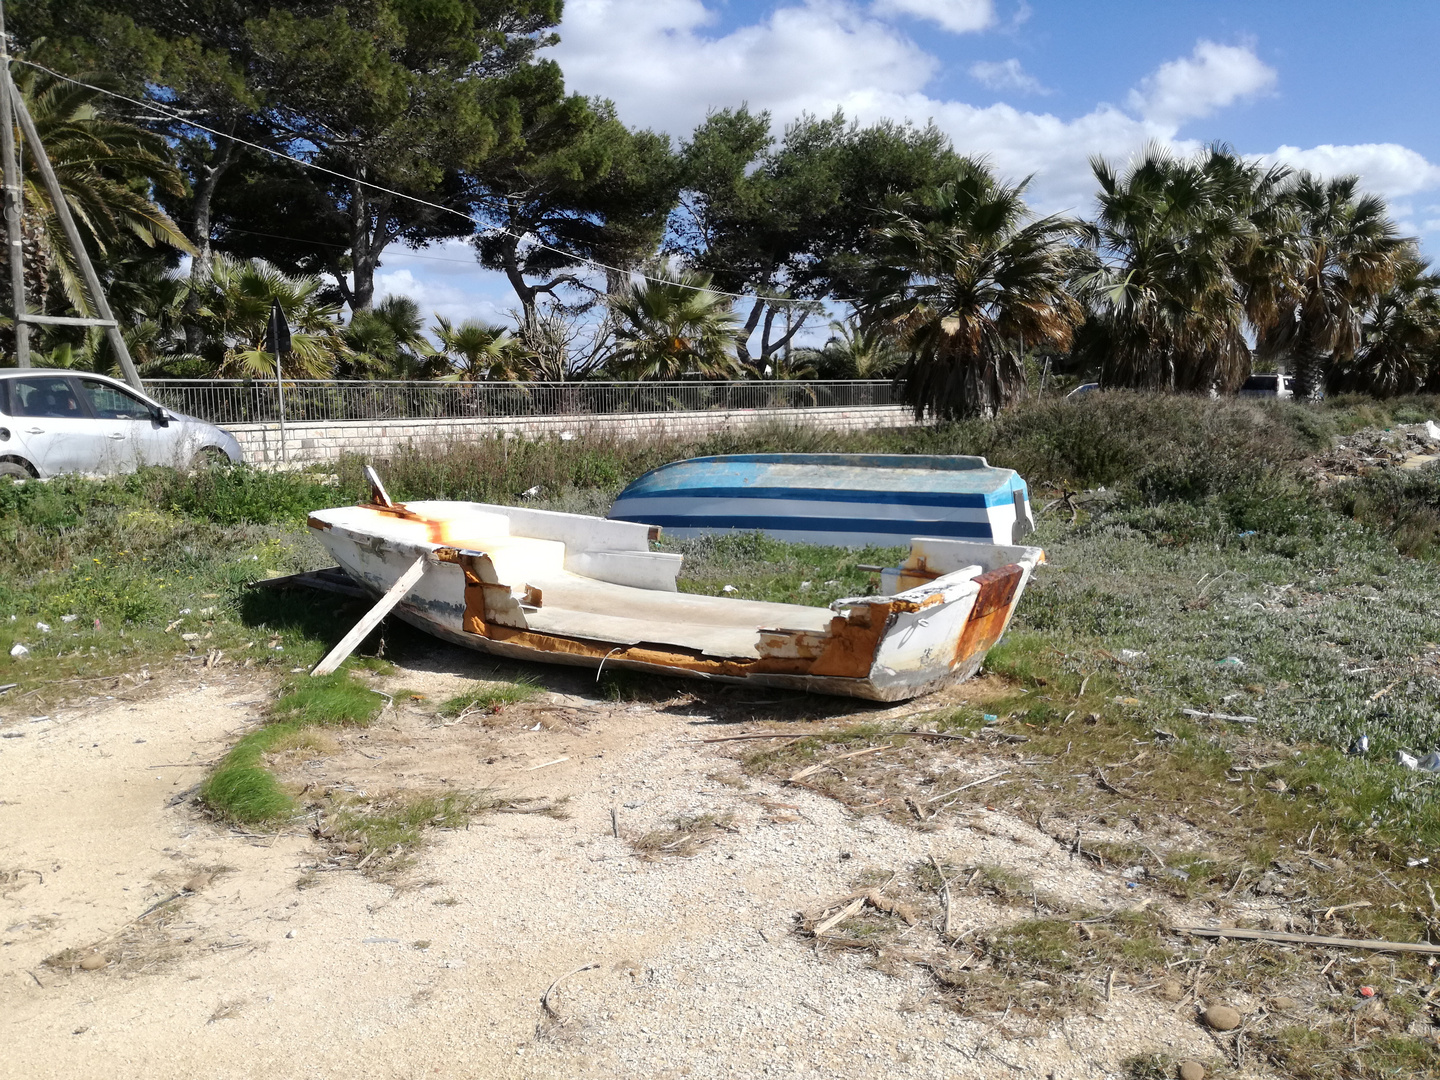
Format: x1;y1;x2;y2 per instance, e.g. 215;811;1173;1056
0;367;242;480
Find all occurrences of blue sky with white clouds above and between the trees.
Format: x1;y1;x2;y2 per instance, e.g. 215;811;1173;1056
377;0;1440;338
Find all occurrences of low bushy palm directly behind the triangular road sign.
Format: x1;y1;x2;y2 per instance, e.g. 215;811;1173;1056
193;255;351;379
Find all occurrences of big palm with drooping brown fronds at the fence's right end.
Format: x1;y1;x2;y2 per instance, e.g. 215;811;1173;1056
863;158;1080;419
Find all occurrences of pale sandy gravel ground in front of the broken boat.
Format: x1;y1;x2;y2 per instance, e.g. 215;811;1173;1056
0;661;1217;1080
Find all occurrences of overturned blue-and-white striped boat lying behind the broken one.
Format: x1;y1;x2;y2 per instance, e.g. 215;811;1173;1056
609;454;1035;547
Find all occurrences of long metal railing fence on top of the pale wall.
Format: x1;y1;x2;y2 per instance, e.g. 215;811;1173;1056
145;379;899;423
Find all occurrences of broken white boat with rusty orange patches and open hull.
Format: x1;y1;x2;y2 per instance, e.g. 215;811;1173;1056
310;484;1044;701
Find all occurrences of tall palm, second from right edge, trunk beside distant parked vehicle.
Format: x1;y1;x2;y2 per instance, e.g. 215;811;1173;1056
1263;173;1408;397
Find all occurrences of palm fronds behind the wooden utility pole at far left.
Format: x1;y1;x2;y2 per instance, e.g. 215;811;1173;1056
0;68;190;311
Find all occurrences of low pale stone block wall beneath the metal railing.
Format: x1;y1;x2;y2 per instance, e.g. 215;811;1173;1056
226;405;914;464
